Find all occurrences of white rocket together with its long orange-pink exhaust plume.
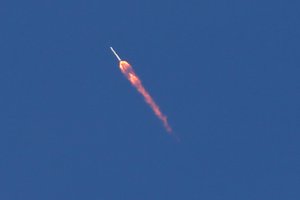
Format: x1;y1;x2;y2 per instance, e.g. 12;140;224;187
110;47;172;134
